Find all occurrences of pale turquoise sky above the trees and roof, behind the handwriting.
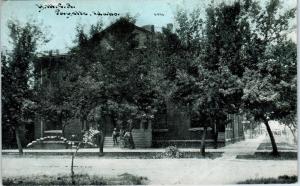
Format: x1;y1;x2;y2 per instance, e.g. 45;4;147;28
0;0;297;52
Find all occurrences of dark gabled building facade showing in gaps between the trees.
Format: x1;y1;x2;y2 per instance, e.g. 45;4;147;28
28;19;244;148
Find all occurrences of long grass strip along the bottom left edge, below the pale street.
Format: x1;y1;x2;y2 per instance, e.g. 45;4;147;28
3;173;148;185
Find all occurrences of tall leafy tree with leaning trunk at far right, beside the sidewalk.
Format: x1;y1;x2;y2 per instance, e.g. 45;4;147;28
242;0;296;155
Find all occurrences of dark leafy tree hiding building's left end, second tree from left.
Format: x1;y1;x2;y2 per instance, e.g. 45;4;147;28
34;51;74;137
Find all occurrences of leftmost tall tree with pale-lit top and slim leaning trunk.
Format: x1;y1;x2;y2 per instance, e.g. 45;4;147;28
2;20;48;154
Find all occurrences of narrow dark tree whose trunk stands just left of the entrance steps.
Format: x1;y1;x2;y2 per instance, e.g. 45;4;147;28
69;28;107;155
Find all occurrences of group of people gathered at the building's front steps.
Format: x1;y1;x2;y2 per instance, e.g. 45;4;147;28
112;128;134;148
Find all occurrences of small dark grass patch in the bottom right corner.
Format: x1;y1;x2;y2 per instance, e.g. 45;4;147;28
238;175;297;184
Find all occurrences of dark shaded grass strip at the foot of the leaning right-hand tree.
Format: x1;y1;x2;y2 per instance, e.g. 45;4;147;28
236;152;297;160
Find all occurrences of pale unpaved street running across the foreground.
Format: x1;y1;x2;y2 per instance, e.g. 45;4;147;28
2;156;297;184
